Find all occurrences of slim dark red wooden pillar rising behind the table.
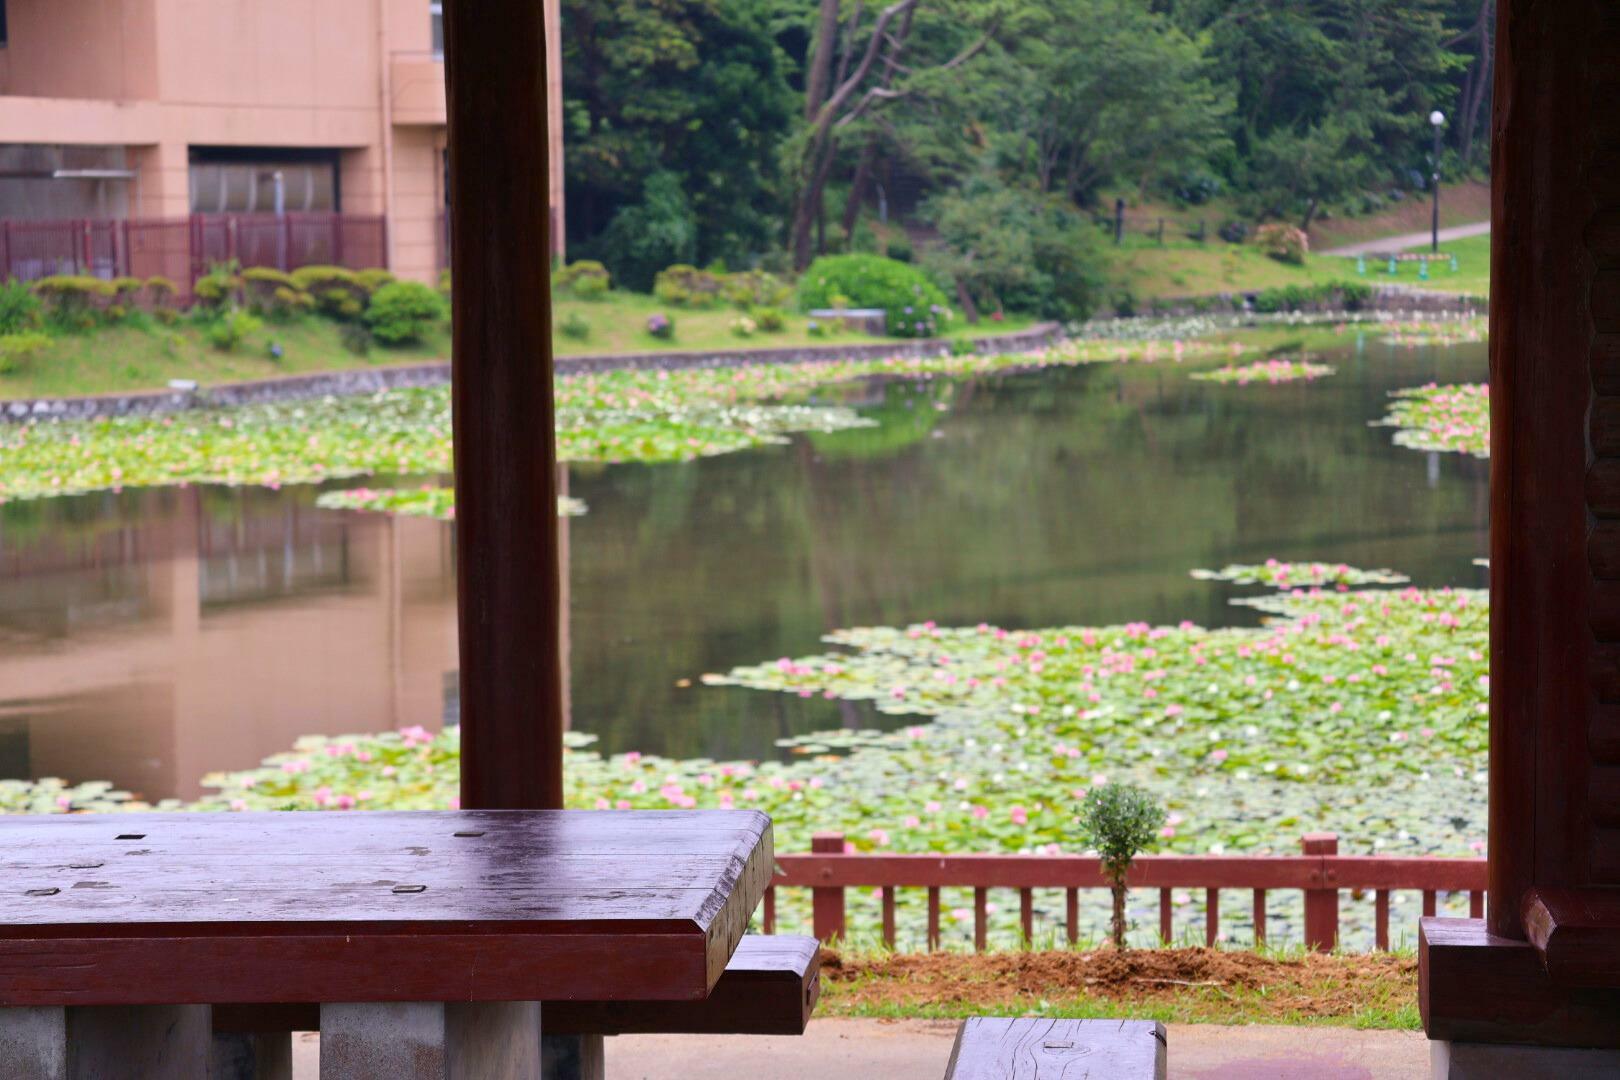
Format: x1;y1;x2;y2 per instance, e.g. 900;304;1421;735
444;0;562;808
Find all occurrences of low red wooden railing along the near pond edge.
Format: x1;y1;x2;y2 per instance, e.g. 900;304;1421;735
763;832;1486;952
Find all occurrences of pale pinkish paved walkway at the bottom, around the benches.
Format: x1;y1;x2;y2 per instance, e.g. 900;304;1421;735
293;1020;1429;1080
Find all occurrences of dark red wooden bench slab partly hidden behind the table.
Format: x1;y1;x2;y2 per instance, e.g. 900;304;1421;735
214;934;821;1035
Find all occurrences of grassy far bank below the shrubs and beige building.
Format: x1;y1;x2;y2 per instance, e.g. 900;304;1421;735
0;293;1035;400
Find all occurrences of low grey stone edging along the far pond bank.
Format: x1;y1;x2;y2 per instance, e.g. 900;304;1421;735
0;322;1063;423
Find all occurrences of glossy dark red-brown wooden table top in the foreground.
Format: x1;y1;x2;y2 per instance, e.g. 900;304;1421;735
0;810;773;1006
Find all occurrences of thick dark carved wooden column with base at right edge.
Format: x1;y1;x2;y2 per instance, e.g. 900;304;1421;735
1419;0;1620;1078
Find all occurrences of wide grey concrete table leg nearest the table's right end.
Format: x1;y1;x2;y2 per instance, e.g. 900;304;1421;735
321;1001;543;1080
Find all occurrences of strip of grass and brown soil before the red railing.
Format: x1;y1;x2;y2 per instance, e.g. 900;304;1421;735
816;947;1421;1031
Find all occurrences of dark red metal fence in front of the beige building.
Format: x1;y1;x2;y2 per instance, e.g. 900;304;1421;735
0;214;387;290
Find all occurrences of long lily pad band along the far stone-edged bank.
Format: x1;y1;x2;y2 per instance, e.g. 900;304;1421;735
0;342;1225;500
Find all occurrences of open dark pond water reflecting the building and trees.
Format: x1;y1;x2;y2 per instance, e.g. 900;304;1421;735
0;337;1487;798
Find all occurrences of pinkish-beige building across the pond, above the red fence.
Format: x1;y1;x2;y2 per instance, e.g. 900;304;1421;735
0;0;479;280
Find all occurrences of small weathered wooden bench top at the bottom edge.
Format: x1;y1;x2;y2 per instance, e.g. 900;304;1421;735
944;1017;1165;1080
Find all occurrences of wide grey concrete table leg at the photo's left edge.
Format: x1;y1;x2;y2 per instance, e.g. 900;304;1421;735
0;1006;212;1080
